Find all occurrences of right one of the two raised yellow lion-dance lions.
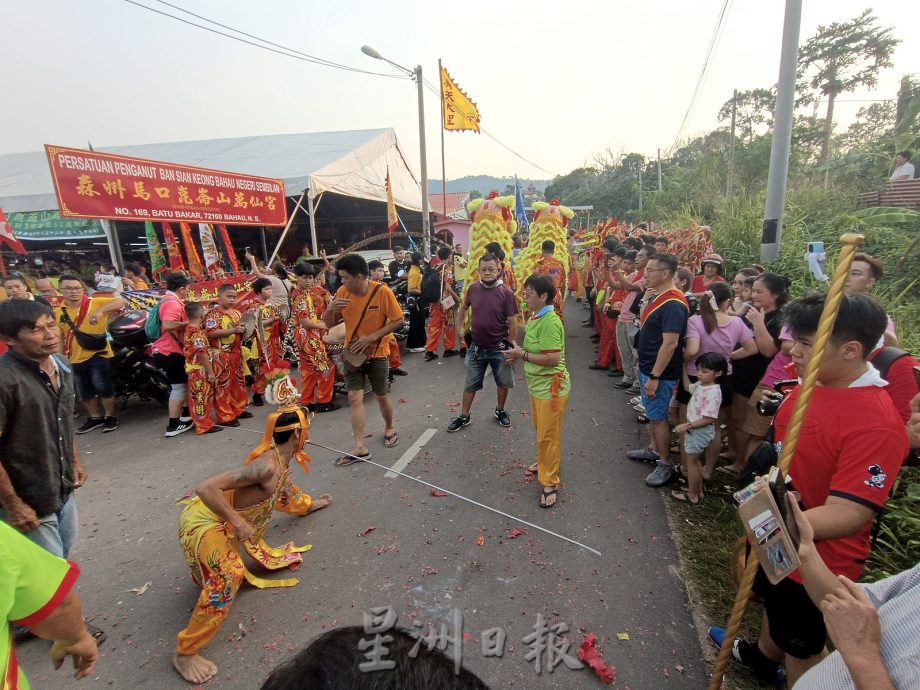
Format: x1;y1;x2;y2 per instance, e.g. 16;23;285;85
514;199;575;319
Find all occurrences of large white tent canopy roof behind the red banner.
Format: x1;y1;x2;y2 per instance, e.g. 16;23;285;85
0;129;422;212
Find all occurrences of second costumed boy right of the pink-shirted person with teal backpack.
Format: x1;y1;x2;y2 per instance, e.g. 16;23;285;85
204;283;252;426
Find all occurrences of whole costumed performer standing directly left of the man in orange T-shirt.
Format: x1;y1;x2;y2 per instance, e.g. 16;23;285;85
291;263;341;412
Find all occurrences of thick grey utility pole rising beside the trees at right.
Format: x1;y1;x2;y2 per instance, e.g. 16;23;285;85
760;0;802;262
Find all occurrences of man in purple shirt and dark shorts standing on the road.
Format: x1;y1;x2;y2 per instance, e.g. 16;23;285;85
447;254;518;433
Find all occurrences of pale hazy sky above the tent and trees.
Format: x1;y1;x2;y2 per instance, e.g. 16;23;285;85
0;0;920;178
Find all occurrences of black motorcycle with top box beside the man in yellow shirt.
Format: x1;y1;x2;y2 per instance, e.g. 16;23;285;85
109;309;170;408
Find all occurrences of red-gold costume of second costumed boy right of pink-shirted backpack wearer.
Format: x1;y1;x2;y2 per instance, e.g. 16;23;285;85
204;306;249;424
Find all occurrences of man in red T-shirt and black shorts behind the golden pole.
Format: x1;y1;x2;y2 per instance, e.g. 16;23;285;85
733;294;908;687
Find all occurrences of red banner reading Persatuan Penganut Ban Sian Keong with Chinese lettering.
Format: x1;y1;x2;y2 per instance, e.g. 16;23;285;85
45;145;287;226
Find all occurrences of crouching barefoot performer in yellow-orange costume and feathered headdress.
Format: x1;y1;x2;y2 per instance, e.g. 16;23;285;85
173;370;332;684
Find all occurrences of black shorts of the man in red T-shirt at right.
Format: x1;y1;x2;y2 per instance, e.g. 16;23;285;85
754;566;827;659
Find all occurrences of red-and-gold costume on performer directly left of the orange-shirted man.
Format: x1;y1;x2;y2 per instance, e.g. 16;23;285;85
291;288;335;405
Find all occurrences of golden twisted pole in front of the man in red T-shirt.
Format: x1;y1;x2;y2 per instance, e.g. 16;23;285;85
709;233;865;690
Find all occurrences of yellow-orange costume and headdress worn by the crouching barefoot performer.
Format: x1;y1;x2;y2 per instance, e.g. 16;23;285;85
176;370;312;656
